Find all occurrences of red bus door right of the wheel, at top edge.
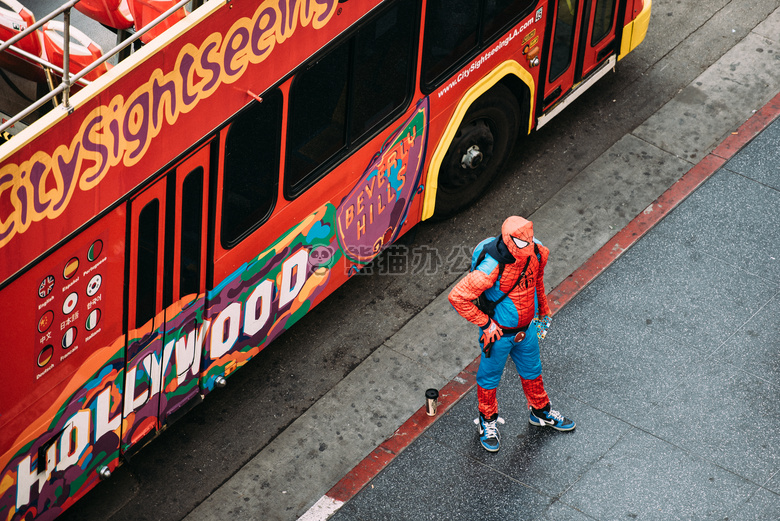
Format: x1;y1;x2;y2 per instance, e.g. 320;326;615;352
540;0;619;111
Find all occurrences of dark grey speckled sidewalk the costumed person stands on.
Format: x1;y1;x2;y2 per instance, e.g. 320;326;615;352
322;96;780;521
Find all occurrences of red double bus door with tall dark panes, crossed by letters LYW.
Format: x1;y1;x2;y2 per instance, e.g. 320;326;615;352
122;145;210;451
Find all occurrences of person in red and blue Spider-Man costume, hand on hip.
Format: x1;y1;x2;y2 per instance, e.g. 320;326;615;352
449;216;575;452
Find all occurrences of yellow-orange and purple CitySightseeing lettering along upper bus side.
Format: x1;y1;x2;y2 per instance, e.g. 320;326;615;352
0;0;338;248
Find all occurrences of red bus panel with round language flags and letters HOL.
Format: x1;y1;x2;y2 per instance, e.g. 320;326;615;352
0;207;125;519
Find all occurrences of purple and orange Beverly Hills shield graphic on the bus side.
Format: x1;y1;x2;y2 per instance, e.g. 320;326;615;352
337;98;428;263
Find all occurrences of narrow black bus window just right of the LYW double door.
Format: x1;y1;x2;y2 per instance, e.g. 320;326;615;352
220;90;282;248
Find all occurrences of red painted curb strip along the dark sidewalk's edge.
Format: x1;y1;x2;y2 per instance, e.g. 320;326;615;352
316;90;780;503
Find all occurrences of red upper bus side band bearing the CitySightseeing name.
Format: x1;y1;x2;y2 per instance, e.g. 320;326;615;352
0;0;380;286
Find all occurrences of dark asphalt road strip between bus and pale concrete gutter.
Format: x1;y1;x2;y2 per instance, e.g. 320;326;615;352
54;0;780;521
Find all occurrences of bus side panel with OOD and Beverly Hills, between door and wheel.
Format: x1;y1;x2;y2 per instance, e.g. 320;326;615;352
201;98;429;393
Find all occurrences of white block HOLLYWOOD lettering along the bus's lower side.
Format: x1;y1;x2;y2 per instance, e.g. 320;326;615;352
10;247;310;510
